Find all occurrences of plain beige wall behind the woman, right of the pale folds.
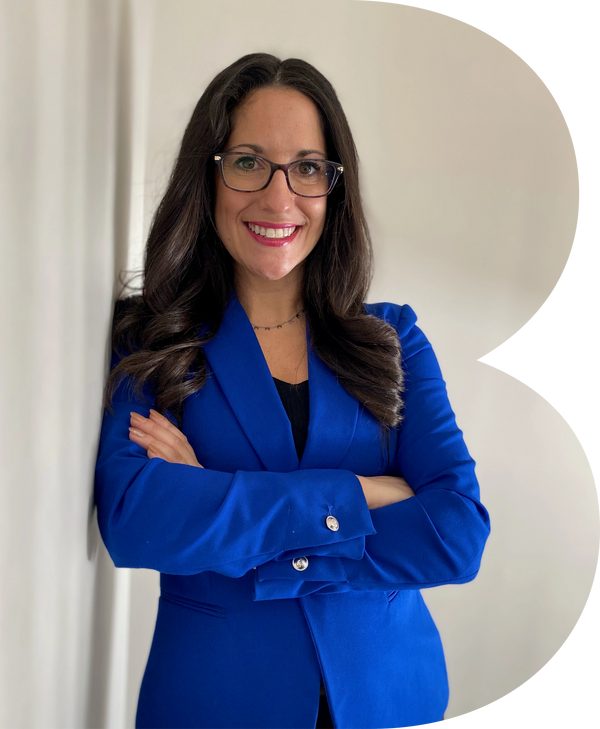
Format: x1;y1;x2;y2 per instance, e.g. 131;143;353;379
129;0;599;727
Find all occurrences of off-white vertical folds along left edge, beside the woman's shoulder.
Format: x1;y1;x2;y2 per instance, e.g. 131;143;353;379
0;0;153;729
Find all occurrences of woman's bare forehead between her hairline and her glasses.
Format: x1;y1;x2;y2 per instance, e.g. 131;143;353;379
228;88;325;148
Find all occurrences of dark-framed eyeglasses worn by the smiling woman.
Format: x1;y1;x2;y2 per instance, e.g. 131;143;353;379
214;152;344;197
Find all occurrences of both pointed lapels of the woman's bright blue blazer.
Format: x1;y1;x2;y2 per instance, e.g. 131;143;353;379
204;292;359;473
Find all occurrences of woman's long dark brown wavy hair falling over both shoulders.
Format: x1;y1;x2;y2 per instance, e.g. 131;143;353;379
103;53;404;466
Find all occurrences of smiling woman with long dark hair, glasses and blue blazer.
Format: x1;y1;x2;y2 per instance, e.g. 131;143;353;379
96;53;489;729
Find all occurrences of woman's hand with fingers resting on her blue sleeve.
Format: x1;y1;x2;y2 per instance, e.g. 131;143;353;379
129;409;204;468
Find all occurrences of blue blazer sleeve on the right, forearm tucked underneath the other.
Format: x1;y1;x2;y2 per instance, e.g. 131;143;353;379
254;306;490;600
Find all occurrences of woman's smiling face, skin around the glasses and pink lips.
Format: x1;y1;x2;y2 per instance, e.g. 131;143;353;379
215;88;327;288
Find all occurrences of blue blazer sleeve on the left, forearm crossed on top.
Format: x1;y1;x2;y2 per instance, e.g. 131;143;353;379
94;355;375;577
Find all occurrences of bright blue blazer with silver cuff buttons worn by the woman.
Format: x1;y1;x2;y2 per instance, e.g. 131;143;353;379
95;294;490;729
